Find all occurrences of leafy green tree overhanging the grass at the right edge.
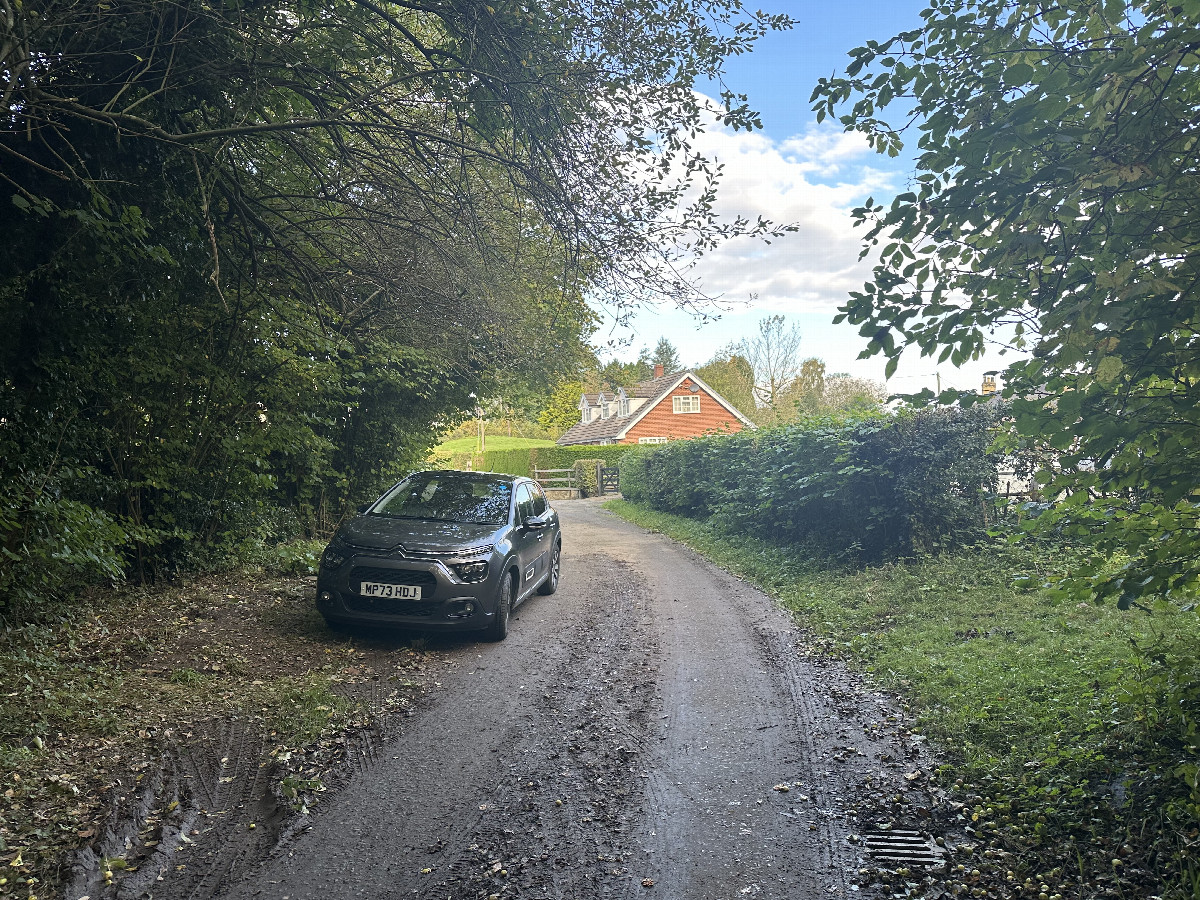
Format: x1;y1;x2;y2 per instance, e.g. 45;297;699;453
812;0;1200;605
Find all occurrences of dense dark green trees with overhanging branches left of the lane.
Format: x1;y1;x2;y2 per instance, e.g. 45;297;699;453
0;0;788;613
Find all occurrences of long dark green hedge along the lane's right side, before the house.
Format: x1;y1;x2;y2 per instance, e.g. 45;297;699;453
620;404;1001;559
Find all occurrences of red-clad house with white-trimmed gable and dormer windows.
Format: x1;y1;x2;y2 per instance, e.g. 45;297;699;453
558;366;755;446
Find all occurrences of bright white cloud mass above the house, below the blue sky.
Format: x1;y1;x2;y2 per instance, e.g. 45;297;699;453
596;103;1009;392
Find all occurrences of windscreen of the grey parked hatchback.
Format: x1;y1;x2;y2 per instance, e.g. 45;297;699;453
370;472;512;526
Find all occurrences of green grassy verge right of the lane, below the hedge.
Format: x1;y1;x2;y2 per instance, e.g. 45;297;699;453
608;500;1200;900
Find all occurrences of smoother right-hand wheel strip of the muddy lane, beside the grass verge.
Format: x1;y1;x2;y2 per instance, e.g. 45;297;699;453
566;506;931;900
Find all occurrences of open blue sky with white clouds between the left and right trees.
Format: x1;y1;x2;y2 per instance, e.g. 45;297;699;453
595;0;1007;392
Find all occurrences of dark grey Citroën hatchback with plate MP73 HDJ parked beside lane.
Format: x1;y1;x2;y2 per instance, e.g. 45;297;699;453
317;470;563;641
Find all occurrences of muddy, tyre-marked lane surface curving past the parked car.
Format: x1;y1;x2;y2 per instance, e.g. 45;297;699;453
149;500;928;900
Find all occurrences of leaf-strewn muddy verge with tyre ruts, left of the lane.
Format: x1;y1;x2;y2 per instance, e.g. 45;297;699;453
0;574;442;900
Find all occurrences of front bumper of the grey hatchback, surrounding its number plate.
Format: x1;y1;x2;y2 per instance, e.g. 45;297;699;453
317;557;499;631
